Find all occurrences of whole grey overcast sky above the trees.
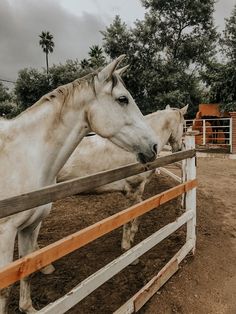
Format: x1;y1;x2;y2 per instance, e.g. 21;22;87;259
0;0;236;80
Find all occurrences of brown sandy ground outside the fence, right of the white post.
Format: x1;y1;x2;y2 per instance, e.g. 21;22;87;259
143;159;236;314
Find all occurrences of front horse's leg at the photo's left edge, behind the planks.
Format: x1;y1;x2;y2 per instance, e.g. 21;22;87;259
0;223;17;314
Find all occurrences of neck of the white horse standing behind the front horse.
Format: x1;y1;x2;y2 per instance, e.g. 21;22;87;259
146;110;172;153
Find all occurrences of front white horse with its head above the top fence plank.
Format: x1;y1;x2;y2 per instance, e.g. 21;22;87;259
0;55;158;314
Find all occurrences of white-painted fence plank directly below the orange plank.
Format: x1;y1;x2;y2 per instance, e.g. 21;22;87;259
39;212;192;314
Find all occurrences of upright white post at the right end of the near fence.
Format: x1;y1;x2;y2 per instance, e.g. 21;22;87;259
185;131;198;254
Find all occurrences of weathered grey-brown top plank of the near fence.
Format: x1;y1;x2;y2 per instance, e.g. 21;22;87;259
0;150;196;218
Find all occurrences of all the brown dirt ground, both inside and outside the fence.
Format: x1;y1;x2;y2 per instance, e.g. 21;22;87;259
10;158;236;314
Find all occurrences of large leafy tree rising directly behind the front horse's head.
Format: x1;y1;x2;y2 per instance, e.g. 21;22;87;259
102;0;217;113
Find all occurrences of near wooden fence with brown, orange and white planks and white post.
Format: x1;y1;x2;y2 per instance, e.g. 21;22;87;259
0;134;197;314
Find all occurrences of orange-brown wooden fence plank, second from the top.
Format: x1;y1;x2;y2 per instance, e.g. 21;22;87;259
0;180;197;288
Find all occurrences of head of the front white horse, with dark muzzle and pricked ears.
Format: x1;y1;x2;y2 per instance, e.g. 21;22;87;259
87;55;158;163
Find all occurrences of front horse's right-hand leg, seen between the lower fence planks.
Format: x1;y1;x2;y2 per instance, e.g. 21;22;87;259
18;223;41;314
